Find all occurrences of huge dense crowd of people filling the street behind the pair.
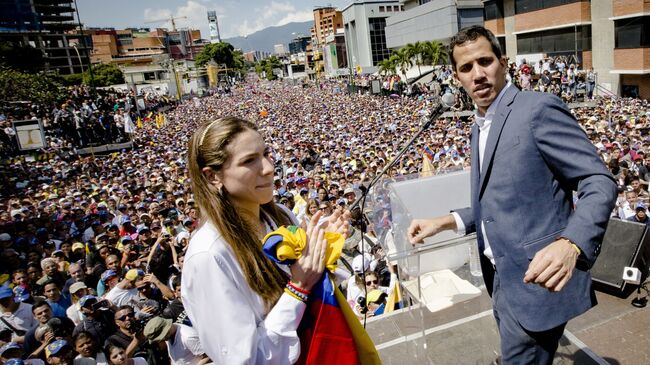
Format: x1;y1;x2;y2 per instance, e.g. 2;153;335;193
0;72;650;364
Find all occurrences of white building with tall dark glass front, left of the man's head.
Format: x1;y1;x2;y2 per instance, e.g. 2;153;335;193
343;0;404;73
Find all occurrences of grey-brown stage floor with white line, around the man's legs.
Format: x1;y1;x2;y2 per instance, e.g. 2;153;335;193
366;282;650;365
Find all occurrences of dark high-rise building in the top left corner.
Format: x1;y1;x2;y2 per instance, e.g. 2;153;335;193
0;0;88;75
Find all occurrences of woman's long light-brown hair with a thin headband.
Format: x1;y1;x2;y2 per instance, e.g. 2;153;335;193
188;117;291;310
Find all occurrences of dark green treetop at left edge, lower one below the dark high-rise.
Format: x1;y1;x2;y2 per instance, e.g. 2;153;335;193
0;66;65;104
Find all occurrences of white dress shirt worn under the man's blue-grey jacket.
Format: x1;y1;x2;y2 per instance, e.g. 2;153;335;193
452;81;512;264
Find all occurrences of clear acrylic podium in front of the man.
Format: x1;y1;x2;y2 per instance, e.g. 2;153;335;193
364;171;600;365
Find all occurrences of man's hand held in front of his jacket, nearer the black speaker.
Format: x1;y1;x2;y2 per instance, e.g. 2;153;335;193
524;238;578;292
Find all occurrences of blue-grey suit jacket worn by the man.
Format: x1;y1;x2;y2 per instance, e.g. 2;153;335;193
457;86;616;331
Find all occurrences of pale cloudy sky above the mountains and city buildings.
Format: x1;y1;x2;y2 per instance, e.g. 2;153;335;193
77;0;352;39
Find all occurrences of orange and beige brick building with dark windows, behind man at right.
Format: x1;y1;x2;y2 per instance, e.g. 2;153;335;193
484;0;650;99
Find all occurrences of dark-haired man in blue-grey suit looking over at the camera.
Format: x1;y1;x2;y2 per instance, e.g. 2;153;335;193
408;26;616;364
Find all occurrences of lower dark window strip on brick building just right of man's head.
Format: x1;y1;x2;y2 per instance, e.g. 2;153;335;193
517;25;591;54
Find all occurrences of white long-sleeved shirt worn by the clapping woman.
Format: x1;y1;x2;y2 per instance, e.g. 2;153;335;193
181;205;306;364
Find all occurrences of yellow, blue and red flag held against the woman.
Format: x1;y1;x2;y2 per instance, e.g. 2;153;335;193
262;226;381;365
